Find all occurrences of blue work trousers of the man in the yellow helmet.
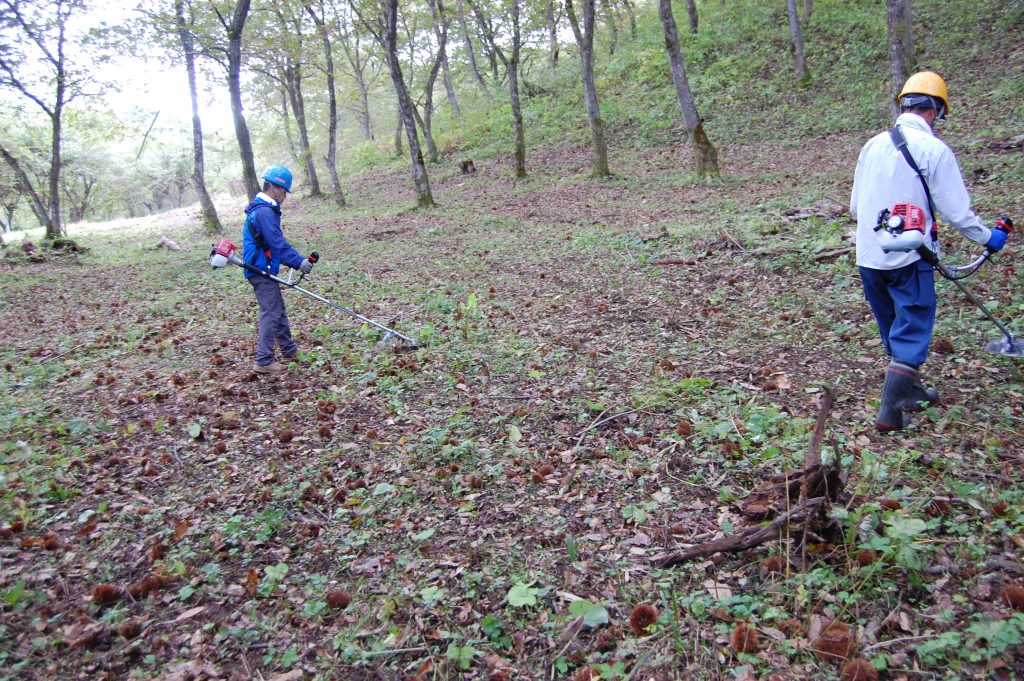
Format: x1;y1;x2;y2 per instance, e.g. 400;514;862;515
860;260;935;368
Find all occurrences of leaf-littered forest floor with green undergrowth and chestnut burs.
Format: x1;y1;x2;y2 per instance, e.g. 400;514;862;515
0;2;1024;680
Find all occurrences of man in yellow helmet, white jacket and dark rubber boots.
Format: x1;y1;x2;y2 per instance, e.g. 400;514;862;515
850;72;1007;431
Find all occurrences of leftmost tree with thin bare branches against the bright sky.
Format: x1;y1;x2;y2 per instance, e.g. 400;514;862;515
0;0;85;240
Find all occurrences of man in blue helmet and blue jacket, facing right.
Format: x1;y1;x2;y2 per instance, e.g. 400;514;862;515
242;166;313;374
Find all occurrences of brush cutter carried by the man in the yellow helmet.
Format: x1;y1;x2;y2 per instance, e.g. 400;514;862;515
874;204;1024;357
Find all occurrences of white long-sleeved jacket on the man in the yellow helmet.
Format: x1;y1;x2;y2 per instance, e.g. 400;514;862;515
850;113;991;269
